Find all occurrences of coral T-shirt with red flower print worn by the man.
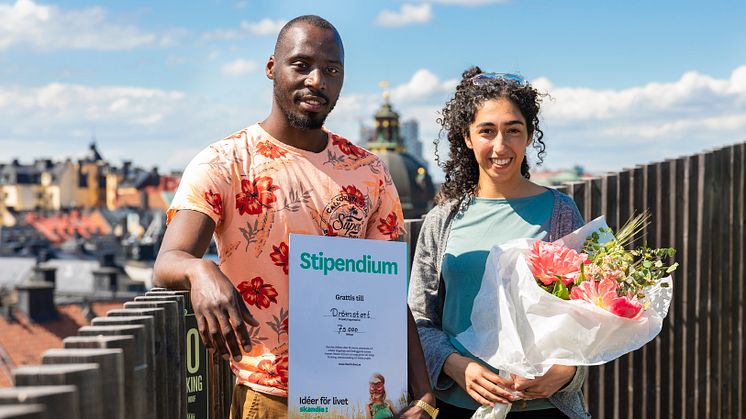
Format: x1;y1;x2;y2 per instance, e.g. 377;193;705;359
168;124;404;396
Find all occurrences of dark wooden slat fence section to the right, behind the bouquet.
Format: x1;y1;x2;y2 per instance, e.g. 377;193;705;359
560;143;746;419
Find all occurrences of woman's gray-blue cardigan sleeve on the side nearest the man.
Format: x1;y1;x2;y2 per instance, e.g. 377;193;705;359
408;207;457;390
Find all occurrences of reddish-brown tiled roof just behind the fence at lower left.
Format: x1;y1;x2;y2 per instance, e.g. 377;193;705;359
0;301;124;387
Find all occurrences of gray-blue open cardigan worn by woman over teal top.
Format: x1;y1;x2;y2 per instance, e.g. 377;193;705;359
408;189;590;419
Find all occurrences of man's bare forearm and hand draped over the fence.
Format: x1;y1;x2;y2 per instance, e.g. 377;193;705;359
153;210;259;361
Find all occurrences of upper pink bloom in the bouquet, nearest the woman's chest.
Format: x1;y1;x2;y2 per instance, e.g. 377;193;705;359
528;240;588;285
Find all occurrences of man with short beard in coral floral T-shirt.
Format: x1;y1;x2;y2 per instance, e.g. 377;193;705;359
155;16;434;418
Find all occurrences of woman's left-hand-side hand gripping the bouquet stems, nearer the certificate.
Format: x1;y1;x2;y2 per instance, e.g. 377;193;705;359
443;353;525;406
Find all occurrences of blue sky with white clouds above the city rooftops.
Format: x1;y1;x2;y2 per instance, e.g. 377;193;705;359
0;0;746;178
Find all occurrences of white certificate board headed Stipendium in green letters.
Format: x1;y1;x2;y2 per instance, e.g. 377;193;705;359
288;234;408;419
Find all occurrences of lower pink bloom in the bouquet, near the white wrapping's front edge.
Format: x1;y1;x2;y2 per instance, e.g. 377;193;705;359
570;278;643;320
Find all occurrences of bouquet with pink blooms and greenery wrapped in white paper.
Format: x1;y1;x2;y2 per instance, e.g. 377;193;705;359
456;214;677;418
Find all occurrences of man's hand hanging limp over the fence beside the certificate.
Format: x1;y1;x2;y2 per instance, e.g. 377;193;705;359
187;260;259;361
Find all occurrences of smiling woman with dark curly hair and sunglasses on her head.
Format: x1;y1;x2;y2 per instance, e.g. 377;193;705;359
409;67;588;418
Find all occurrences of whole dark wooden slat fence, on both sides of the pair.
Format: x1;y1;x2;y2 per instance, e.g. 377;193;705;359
0;143;746;419
